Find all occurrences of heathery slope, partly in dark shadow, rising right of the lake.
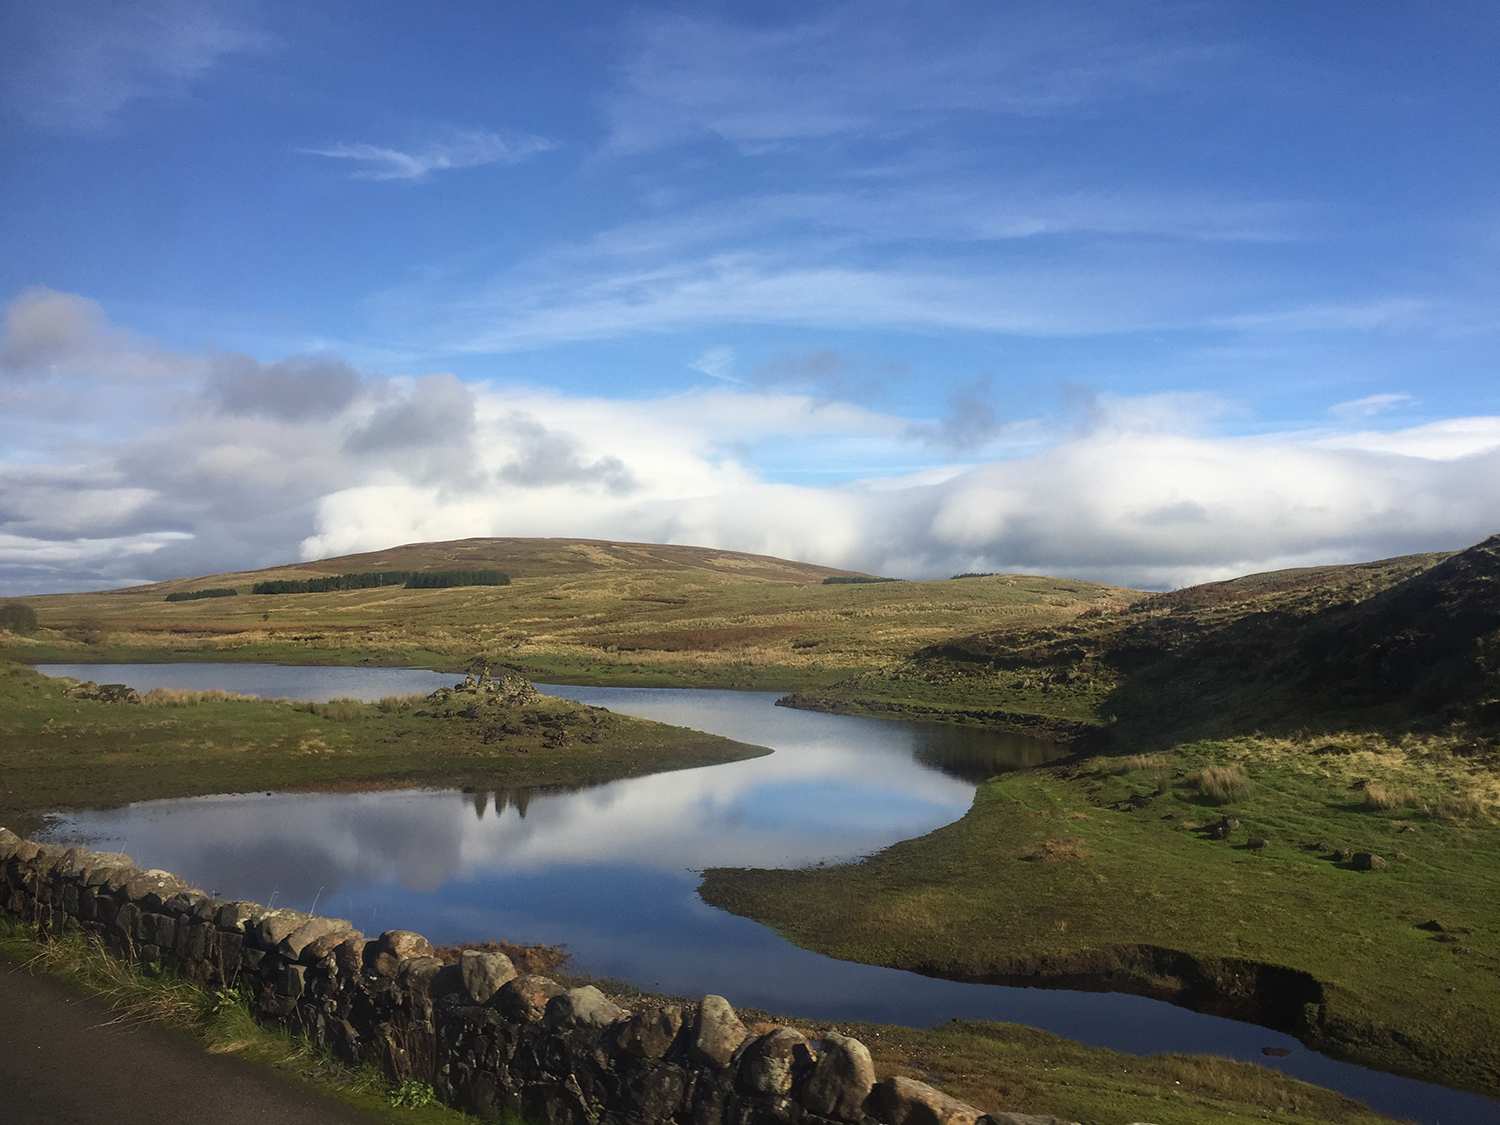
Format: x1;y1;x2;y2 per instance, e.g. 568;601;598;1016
786;540;1476;749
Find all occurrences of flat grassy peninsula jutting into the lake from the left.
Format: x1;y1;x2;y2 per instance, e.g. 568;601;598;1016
0;663;770;831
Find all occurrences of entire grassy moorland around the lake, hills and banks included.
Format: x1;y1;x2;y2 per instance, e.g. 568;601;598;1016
0;540;1500;1121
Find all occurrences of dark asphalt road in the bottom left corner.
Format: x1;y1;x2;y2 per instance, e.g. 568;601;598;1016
0;959;381;1125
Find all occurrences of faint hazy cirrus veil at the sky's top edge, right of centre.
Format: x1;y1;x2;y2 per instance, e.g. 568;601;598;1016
608;3;1205;152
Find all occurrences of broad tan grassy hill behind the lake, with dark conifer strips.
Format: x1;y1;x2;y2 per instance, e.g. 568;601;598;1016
0;539;1140;689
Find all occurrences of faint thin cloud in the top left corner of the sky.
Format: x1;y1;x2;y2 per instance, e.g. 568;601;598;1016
0;0;270;132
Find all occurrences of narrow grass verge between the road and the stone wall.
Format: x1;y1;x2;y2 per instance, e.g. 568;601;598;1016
0;917;474;1125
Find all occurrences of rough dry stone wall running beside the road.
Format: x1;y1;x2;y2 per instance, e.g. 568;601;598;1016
0;828;1092;1125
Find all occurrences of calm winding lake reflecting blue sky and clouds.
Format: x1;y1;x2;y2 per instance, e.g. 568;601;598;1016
39;665;1500;1125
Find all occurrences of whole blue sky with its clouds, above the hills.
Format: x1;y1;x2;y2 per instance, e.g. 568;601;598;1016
0;0;1500;593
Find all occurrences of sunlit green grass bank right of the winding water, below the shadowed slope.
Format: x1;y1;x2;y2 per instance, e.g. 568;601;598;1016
702;737;1500;1104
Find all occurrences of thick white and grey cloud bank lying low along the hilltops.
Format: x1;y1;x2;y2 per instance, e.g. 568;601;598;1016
0;294;1500;593
